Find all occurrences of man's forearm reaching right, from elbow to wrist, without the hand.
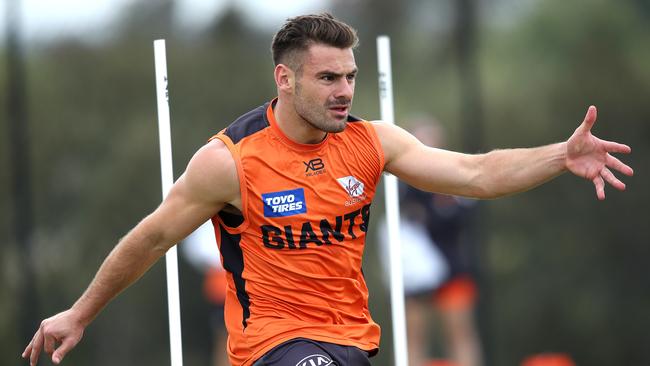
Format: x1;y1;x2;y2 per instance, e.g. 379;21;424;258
473;143;566;198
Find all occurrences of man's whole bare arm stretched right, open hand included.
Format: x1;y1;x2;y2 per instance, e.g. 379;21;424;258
375;106;633;199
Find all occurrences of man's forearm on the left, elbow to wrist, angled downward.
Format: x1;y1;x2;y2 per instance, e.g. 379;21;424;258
72;219;168;325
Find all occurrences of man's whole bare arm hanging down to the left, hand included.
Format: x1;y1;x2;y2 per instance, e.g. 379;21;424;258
22;140;239;366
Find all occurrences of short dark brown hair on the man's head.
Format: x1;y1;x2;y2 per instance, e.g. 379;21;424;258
271;13;359;67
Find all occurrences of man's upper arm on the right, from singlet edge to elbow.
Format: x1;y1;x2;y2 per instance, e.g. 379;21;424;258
375;123;479;197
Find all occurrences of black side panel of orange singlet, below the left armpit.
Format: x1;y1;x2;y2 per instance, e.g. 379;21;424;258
219;225;251;329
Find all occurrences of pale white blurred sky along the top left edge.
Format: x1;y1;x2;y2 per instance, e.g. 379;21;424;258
0;0;328;40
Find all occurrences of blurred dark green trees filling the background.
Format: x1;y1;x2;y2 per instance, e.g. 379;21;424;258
0;0;650;366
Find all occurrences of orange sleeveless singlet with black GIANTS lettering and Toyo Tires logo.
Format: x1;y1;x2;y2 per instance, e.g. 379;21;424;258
213;101;384;365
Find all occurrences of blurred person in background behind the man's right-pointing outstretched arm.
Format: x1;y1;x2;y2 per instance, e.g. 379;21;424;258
380;117;483;366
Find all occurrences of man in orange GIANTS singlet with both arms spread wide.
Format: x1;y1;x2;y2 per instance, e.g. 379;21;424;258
23;14;632;366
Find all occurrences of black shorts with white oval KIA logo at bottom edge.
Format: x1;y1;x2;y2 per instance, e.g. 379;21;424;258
253;338;370;366
